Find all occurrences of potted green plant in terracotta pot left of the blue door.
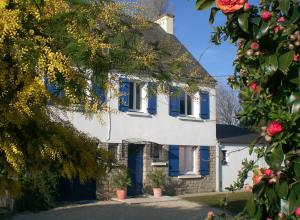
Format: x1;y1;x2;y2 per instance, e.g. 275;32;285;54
112;169;131;200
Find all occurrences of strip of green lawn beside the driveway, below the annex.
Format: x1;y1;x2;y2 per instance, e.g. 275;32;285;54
184;192;251;215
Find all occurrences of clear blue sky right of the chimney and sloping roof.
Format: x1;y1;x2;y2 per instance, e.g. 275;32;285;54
170;0;236;84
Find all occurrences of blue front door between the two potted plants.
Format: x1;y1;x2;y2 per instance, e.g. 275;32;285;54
127;144;144;196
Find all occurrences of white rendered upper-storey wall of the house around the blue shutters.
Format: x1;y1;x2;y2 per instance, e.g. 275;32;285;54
67;81;216;146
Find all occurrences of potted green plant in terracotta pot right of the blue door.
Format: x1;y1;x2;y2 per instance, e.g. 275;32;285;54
148;170;166;198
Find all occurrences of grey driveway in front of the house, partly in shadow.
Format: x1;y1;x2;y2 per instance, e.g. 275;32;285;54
12;198;223;220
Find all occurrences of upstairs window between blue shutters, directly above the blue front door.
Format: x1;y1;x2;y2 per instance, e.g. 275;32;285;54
129;82;142;111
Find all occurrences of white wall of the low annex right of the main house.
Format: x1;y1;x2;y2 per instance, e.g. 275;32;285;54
220;144;267;191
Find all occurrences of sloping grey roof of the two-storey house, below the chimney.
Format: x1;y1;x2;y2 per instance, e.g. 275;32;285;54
126;17;217;86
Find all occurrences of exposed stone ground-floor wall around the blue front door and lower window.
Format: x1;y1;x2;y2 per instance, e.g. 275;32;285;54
96;144;216;200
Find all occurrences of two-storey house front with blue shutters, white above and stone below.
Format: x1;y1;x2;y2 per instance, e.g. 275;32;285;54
63;15;217;198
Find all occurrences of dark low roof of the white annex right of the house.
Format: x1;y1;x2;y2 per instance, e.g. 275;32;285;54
217;124;264;144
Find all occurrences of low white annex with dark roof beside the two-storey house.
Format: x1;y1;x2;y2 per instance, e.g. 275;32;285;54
216;124;267;191
